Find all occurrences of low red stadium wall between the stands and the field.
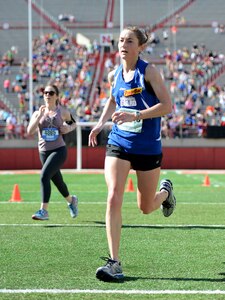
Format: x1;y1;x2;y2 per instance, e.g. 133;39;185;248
0;139;225;170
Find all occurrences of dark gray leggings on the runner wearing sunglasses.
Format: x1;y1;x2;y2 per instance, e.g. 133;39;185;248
39;147;69;203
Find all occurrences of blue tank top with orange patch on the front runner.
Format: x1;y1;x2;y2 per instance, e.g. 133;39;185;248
108;59;162;155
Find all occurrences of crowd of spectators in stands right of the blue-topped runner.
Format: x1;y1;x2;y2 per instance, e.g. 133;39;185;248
157;44;225;138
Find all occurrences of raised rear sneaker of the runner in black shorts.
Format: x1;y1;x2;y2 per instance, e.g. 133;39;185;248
159;179;176;217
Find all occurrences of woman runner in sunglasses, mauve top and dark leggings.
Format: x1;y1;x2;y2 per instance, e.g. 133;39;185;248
27;85;78;220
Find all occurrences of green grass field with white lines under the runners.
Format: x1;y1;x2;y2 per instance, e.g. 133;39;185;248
0;171;225;300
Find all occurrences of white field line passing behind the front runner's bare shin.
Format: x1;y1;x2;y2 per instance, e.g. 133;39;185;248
0;222;225;229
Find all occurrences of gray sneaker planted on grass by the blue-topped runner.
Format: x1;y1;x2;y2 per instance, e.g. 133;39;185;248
96;257;124;281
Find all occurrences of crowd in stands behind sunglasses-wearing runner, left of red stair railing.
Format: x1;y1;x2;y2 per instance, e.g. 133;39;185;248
0;33;102;139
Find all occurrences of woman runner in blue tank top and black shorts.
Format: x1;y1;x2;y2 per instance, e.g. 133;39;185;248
89;27;176;281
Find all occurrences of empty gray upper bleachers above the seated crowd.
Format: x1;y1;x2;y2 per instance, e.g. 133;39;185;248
0;0;225;141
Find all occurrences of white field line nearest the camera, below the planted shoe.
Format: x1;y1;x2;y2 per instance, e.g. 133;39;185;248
0;289;225;295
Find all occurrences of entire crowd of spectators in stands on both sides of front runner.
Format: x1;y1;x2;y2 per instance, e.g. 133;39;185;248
0;28;225;139
